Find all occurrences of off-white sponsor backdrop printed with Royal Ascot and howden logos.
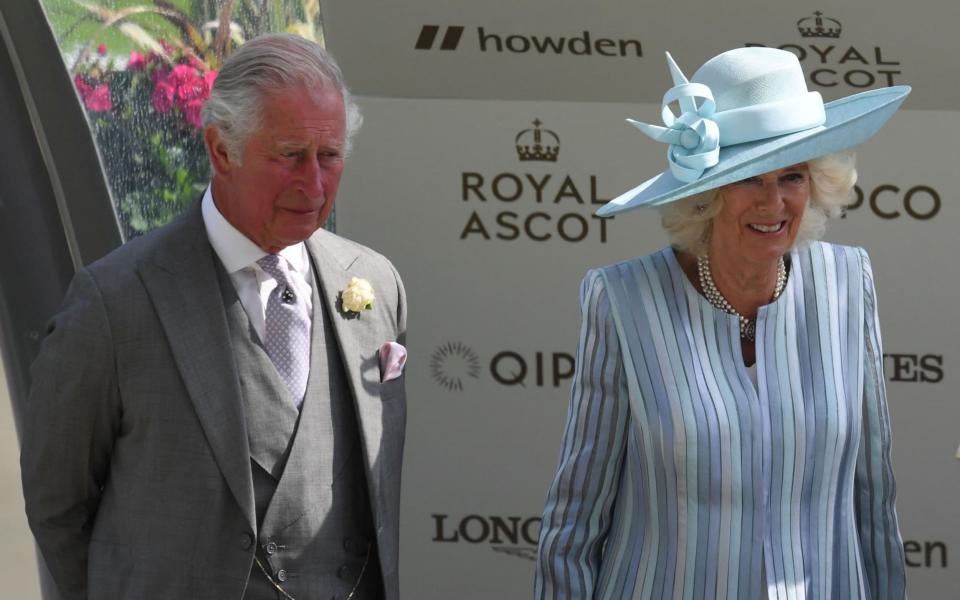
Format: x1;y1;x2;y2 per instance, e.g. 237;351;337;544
325;2;960;600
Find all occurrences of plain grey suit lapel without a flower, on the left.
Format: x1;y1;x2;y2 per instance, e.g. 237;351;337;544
138;203;256;530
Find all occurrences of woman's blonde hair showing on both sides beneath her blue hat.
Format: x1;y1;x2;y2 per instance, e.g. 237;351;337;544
659;151;857;256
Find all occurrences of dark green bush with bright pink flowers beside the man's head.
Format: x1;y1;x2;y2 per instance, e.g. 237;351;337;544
75;44;215;238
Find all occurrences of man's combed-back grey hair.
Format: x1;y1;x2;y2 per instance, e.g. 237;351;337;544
201;33;363;161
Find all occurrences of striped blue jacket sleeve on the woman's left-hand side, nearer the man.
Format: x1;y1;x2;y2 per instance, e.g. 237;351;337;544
535;271;629;599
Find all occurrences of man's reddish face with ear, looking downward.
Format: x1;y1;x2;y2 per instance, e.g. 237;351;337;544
206;88;346;253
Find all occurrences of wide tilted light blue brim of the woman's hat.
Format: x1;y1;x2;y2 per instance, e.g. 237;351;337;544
596;85;910;217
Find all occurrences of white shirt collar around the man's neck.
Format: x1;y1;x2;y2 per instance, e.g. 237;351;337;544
200;186;310;275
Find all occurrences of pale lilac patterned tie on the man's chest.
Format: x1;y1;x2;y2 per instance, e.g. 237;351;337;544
257;254;310;409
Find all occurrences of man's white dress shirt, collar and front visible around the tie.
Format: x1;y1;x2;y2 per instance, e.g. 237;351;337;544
200;186;313;340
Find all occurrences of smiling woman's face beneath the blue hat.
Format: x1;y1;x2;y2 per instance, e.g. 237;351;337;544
710;163;810;263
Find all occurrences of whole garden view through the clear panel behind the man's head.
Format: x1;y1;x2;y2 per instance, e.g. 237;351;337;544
41;0;322;239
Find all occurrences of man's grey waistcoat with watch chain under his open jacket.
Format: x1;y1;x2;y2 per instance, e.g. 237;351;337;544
220;258;383;600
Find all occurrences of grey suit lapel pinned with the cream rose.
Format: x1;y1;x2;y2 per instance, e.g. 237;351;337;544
307;234;383;522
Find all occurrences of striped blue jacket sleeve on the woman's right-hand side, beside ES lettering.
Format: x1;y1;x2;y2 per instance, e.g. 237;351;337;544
854;249;906;600
